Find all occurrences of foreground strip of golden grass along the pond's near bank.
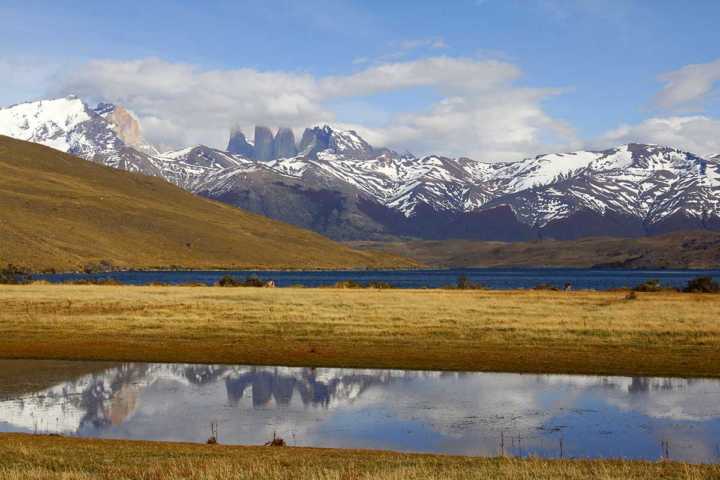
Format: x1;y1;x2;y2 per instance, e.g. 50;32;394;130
0;434;720;480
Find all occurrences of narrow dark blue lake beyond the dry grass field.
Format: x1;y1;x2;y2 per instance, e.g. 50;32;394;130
35;268;720;290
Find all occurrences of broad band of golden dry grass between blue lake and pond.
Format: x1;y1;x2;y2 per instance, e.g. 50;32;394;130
0;285;720;377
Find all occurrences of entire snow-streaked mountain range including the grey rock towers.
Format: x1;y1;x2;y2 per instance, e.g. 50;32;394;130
0;97;720;241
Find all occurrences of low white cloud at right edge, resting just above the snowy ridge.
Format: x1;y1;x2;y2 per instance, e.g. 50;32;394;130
596;115;720;156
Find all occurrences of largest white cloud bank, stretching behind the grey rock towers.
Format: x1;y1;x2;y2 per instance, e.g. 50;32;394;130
55;56;575;160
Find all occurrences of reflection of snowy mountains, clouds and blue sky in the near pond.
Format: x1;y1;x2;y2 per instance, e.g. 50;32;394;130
0;362;720;462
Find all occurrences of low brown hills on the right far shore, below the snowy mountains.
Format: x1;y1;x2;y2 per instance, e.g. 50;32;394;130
349;231;720;268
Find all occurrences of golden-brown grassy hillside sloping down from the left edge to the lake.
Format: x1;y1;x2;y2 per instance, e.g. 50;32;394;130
0;136;413;270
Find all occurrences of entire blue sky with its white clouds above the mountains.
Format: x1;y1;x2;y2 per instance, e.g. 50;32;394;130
0;0;720;161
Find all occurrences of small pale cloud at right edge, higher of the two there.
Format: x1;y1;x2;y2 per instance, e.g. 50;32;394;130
655;59;720;108
